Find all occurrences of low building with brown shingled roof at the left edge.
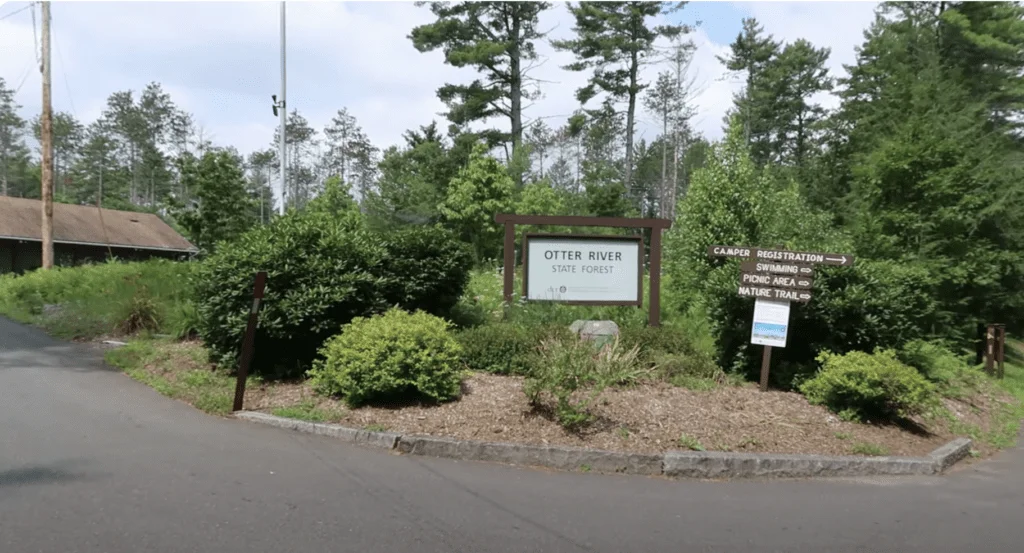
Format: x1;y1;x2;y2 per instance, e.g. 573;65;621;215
0;197;199;273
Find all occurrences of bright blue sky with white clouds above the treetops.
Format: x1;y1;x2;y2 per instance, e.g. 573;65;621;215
0;1;877;154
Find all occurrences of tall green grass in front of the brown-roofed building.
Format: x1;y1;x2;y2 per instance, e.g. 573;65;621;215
0;259;197;339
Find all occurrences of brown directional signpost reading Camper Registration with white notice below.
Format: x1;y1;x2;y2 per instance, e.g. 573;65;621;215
708;246;853;391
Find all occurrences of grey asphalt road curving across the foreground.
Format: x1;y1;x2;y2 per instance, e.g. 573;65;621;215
0;318;1024;553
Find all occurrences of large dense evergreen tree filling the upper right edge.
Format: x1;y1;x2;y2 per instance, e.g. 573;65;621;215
839;3;1024;338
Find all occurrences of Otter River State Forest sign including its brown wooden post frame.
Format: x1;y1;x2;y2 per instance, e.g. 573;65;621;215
495;213;672;327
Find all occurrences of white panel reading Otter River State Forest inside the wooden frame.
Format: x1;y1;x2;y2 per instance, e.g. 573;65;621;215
526;236;642;305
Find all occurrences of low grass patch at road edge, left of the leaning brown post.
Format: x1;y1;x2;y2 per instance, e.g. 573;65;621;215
104;339;237;415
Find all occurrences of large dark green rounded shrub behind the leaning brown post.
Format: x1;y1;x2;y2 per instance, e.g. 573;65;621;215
195;210;468;378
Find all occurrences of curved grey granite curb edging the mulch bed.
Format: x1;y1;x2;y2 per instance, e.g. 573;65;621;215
234;411;972;479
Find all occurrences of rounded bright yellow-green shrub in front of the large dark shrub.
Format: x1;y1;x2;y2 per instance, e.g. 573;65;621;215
309;308;462;407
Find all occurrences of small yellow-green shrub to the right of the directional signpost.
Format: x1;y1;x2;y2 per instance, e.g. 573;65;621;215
800;350;937;421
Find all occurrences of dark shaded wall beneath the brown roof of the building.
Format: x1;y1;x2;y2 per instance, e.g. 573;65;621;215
0;240;188;274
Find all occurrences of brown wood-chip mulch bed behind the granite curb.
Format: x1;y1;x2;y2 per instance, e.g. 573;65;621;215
246;374;1009;456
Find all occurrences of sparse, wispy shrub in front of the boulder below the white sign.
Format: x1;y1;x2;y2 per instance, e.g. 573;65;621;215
522;337;647;430
